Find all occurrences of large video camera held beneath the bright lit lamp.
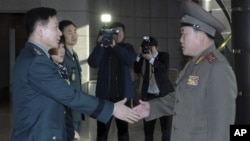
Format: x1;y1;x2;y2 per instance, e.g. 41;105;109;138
100;28;120;48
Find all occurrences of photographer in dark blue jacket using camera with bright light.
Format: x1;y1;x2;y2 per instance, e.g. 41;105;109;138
88;22;136;141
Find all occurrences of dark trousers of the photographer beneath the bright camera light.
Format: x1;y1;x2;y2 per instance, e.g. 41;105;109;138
96;118;129;141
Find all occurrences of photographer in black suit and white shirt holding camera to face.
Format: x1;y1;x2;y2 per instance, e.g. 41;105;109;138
134;36;174;141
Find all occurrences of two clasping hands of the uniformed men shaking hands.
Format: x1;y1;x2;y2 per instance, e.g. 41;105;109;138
113;98;150;123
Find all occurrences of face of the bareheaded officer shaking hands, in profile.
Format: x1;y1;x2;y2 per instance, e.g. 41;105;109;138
38;16;62;50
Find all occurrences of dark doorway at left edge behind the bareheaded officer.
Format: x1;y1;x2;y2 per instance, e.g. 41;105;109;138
0;13;27;106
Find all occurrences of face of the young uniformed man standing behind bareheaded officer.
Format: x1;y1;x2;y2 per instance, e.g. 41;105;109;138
63;24;78;47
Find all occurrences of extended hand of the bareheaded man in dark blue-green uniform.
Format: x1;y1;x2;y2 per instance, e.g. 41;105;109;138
113;98;139;123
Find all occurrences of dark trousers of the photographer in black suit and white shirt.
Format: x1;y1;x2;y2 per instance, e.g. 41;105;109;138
143;116;172;141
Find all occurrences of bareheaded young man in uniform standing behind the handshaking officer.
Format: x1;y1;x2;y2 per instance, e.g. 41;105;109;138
59;20;84;133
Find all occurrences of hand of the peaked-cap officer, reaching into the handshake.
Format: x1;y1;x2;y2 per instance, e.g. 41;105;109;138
133;100;150;119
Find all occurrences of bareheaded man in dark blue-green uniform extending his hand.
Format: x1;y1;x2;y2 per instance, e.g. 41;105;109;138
11;7;139;141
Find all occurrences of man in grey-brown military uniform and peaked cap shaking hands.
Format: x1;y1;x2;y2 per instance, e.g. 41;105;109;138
134;1;237;141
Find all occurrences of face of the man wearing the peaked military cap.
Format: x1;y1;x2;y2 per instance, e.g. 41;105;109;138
180;26;201;57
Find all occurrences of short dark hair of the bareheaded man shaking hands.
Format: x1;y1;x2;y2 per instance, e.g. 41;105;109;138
24;7;57;36
